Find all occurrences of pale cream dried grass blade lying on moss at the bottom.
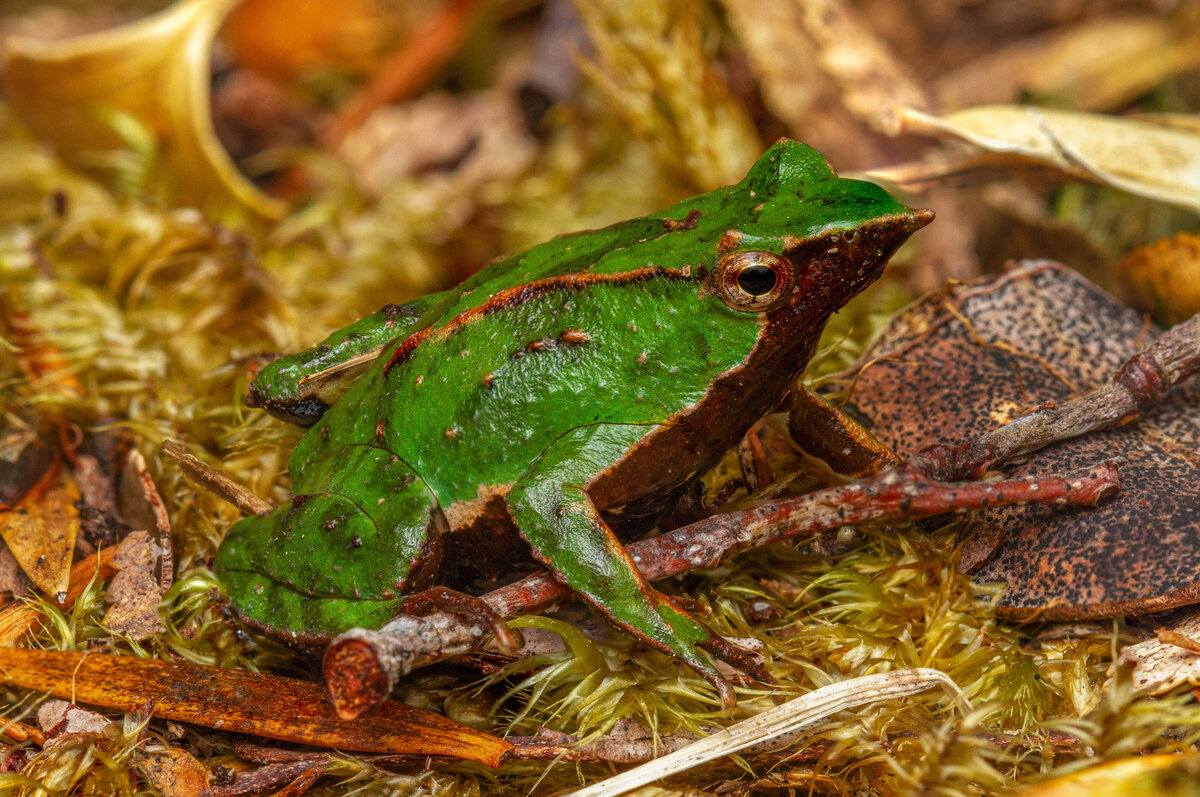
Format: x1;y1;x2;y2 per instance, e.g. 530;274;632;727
570;667;958;797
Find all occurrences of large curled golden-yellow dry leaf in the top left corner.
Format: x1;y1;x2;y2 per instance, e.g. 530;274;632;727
4;0;286;218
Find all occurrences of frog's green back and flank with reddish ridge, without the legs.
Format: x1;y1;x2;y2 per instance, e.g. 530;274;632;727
293;143;902;507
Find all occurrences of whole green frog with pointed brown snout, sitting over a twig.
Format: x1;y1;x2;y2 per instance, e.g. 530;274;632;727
216;140;931;679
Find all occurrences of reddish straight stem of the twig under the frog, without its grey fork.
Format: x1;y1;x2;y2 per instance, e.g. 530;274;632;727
324;463;1118;719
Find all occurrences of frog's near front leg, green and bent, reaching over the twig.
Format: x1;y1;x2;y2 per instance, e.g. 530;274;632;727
508;424;766;703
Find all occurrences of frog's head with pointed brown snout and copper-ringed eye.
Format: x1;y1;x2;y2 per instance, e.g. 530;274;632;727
707;139;934;344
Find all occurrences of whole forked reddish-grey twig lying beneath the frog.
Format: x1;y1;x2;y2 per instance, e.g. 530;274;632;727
324;316;1200;718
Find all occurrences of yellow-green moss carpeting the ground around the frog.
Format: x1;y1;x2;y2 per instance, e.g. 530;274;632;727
0;4;1200;795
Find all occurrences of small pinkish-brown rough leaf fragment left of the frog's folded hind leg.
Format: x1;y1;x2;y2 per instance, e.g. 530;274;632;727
101;532;164;640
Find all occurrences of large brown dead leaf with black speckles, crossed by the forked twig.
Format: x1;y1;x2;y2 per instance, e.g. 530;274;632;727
850;262;1200;619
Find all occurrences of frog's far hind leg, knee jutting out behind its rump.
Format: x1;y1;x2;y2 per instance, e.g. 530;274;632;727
246;294;444;426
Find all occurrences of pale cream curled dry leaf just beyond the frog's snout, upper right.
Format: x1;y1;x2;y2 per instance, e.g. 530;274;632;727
868;106;1200;210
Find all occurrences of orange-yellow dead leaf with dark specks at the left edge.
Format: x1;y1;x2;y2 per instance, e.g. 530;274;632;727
0;472;79;600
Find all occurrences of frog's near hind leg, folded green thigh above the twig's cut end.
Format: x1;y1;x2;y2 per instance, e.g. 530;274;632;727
216;445;445;645
